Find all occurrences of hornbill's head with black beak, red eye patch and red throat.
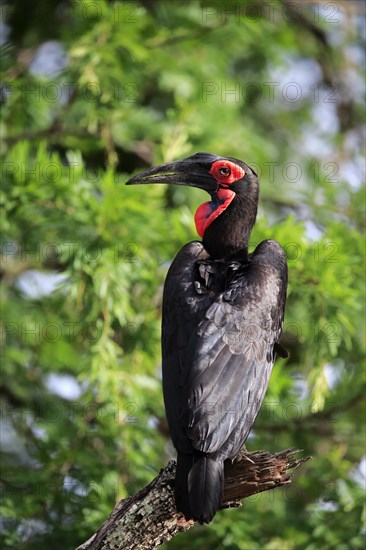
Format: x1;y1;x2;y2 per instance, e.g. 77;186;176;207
127;153;258;243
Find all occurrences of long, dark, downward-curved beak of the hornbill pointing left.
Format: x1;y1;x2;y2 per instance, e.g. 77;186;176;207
126;158;218;194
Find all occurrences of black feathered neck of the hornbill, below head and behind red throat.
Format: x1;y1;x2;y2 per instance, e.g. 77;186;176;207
202;190;258;259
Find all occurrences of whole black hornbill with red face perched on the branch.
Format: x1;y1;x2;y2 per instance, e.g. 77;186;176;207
127;153;287;523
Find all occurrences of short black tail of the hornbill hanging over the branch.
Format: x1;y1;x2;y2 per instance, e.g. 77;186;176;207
175;453;224;523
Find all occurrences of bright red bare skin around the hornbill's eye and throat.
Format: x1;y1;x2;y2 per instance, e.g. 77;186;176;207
194;160;245;237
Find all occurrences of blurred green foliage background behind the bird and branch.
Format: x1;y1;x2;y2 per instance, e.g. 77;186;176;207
0;0;366;550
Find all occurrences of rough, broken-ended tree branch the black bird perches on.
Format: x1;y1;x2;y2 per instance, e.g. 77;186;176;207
77;449;311;550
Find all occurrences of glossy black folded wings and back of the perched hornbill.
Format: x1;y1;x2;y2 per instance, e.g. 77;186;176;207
162;241;287;459
